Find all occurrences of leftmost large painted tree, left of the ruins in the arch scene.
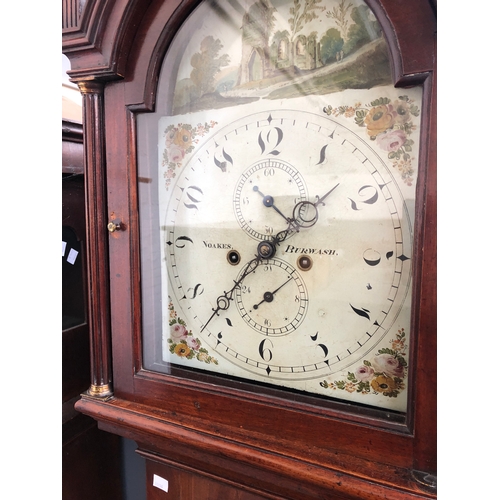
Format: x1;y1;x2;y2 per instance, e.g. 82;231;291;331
190;36;229;97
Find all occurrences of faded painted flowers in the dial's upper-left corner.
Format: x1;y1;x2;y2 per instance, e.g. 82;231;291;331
162;121;217;190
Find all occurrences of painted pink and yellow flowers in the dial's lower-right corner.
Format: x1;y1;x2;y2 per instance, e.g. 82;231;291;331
320;328;408;398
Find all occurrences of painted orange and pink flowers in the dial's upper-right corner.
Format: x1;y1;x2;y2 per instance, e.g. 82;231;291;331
323;95;420;186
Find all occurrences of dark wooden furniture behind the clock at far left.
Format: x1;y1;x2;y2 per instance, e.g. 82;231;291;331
62;121;122;500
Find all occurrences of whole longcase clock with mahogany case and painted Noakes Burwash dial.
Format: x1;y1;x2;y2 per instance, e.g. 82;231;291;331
63;0;437;500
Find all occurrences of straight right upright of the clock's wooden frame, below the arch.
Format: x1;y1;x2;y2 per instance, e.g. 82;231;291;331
408;58;437;475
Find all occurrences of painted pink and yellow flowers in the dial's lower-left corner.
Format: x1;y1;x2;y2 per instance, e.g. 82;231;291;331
167;301;219;365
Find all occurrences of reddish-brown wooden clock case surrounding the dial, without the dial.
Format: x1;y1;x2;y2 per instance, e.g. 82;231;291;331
63;0;436;500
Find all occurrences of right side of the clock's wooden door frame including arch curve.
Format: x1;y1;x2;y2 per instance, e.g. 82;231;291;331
367;0;437;476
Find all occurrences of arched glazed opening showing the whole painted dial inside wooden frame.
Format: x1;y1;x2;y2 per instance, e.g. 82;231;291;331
138;0;422;414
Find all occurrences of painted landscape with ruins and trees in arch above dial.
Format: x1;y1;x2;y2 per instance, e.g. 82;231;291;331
173;0;392;114
